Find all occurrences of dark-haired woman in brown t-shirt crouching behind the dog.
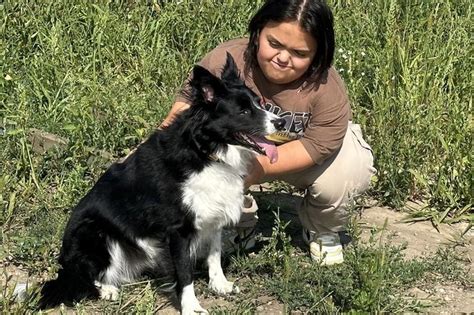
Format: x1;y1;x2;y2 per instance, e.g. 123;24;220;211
161;0;375;265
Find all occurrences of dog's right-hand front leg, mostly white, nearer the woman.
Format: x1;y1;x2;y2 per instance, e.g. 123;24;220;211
207;229;239;294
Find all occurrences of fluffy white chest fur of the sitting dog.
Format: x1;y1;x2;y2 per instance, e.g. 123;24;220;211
183;163;244;231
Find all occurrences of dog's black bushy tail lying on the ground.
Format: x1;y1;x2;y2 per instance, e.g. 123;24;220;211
38;269;99;309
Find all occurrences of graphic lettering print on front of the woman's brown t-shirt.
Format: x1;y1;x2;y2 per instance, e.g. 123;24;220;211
262;101;311;143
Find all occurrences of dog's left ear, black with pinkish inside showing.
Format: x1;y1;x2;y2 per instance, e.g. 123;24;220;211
190;66;224;103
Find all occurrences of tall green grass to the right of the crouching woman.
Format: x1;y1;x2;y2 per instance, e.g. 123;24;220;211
332;0;474;220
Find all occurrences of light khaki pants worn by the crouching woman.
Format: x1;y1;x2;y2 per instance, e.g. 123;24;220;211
241;122;376;233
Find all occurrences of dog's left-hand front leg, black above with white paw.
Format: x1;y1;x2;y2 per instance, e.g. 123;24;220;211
170;232;207;315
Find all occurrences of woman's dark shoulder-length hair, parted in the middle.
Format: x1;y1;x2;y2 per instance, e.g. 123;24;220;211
244;0;335;79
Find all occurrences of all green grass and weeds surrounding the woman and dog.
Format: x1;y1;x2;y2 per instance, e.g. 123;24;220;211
0;0;474;313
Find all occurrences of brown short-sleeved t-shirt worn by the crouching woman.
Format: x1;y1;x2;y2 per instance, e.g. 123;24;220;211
176;38;352;164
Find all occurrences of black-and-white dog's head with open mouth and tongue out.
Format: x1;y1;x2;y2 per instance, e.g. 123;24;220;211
190;54;284;162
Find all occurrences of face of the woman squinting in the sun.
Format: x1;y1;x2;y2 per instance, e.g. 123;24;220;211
257;21;316;84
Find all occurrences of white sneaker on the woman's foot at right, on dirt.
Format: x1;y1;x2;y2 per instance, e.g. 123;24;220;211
303;229;344;266
